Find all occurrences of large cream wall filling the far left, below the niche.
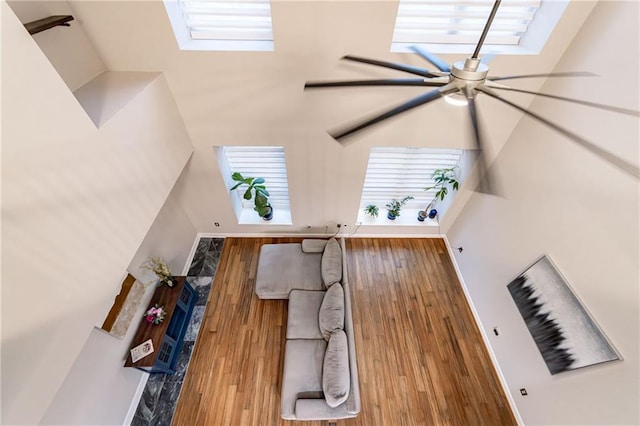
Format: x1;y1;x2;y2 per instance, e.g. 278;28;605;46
1;2;192;424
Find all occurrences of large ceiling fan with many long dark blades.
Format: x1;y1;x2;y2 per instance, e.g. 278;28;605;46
305;0;640;194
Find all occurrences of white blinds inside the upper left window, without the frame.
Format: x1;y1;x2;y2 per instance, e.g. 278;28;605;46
179;0;273;42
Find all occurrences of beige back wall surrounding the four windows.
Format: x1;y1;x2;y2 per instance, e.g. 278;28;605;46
66;1;593;235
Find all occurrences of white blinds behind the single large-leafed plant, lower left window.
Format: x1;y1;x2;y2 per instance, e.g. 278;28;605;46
222;146;289;209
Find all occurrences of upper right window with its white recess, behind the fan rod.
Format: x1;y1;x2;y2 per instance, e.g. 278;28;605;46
391;0;568;55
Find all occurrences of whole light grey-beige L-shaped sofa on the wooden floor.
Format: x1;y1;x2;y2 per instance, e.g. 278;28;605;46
256;239;360;420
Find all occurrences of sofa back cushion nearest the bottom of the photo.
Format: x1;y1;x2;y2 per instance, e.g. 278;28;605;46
322;330;351;407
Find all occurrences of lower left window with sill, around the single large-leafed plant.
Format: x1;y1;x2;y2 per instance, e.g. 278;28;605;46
215;146;291;225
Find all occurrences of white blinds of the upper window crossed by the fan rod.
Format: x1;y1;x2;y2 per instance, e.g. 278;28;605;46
393;0;541;45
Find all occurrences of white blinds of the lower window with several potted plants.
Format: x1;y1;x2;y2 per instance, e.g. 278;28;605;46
360;147;462;212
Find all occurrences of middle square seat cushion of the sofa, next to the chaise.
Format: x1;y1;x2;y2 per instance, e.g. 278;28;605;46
287;290;325;339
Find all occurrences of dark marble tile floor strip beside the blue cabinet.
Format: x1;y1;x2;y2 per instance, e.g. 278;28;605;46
131;238;224;426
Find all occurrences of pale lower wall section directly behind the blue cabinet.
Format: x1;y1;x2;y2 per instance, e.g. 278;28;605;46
42;182;197;425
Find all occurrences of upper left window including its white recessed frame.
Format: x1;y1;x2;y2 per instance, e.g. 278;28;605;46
164;0;274;51
